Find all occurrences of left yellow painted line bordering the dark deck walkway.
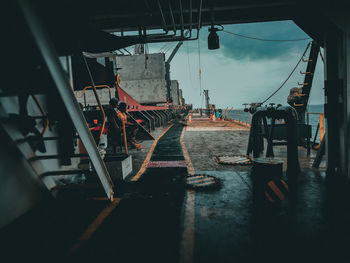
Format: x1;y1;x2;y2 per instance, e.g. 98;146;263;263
68;124;174;255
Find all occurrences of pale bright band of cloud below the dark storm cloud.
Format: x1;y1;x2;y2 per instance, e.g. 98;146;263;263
171;51;323;108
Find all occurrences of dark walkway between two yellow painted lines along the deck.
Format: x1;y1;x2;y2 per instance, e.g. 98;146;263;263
70;123;187;262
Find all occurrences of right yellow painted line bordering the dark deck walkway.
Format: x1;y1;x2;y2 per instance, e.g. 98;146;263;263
179;127;195;263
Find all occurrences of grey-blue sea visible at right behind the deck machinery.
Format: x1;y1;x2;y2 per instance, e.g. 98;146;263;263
227;104;324;142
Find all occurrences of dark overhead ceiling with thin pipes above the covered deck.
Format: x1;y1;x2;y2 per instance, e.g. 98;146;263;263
22;0;344;54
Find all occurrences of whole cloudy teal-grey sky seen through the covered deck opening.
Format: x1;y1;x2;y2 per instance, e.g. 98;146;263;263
149;21;324;108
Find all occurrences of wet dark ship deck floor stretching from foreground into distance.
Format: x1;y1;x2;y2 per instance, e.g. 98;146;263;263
2;118;350;262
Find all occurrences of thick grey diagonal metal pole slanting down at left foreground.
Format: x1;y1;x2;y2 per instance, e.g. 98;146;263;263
17;0;114;200
